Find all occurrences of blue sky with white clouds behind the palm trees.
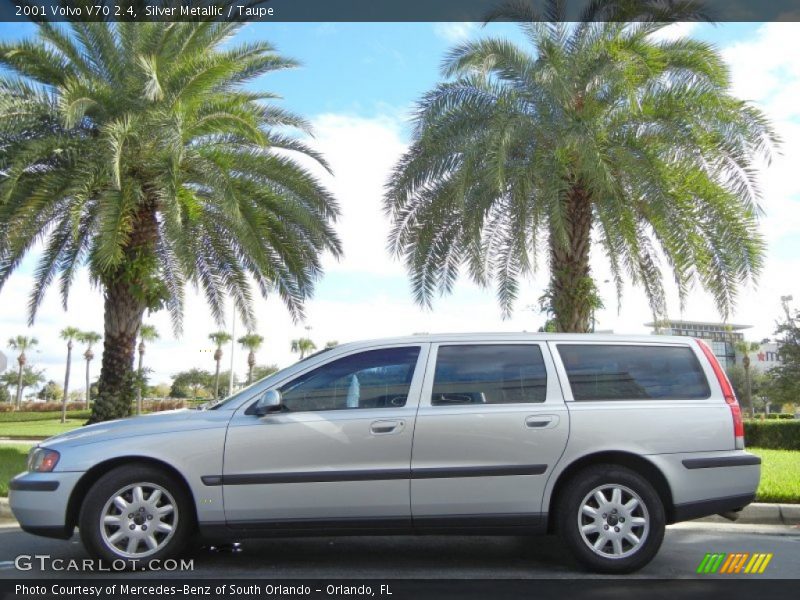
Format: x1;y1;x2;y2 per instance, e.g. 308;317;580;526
0;23;800;390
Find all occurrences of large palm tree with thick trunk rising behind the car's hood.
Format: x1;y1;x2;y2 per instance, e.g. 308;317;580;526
0;17;341;421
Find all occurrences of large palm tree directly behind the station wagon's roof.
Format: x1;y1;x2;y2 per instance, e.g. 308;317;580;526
384;0;777;332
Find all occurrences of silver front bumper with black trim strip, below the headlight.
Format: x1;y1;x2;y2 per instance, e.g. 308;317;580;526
8;472;83;538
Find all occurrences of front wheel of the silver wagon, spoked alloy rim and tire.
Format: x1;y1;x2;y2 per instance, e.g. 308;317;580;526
78;465;193;567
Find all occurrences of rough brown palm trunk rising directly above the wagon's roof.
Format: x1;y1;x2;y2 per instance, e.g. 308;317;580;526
550;184;594;333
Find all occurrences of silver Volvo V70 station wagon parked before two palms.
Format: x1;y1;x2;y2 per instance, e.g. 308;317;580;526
10;334;760;573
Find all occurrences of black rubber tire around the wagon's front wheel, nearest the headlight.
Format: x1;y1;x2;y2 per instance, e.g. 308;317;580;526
78;464;195;569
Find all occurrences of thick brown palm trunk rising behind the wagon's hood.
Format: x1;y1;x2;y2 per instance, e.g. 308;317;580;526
89;276;145;423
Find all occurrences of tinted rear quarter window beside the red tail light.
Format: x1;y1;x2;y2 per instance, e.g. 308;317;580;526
557;344;711;401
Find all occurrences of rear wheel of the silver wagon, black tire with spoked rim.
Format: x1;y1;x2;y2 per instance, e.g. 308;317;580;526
557;464;665;573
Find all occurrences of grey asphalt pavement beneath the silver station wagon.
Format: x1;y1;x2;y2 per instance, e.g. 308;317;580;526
0;522;800;579
